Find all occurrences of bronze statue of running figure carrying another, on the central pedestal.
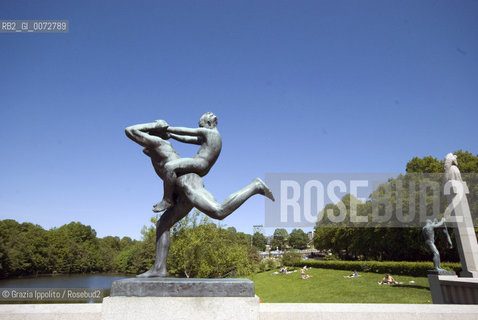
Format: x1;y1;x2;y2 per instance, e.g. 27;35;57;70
125;112;274;278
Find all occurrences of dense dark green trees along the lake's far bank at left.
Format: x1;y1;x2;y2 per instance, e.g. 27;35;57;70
0;219;137;277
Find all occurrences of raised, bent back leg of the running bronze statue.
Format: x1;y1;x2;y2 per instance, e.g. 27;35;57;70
184;178;274;220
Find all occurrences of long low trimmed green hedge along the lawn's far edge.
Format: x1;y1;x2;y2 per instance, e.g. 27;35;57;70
291;260;461;277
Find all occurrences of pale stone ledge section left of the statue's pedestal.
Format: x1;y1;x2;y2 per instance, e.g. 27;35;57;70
0;303;102;320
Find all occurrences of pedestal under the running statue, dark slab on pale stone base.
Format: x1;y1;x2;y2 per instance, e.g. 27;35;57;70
101;278;259;320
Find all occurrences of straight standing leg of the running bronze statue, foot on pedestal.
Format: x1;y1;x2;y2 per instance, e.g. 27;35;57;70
136;198;193;278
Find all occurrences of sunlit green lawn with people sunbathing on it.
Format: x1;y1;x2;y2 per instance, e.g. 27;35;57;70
249;268;432;303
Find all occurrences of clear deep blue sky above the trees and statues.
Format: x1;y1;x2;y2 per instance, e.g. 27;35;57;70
0;0;478;238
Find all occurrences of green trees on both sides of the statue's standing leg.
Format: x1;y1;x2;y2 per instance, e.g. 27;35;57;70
0;212;259;278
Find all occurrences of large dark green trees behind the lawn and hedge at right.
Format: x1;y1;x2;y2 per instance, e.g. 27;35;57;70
314;150;478;262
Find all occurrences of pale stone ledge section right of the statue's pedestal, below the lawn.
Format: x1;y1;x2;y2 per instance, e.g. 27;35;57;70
259;303;478;320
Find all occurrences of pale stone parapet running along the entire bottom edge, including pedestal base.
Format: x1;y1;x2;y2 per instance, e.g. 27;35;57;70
0;298;478;320
